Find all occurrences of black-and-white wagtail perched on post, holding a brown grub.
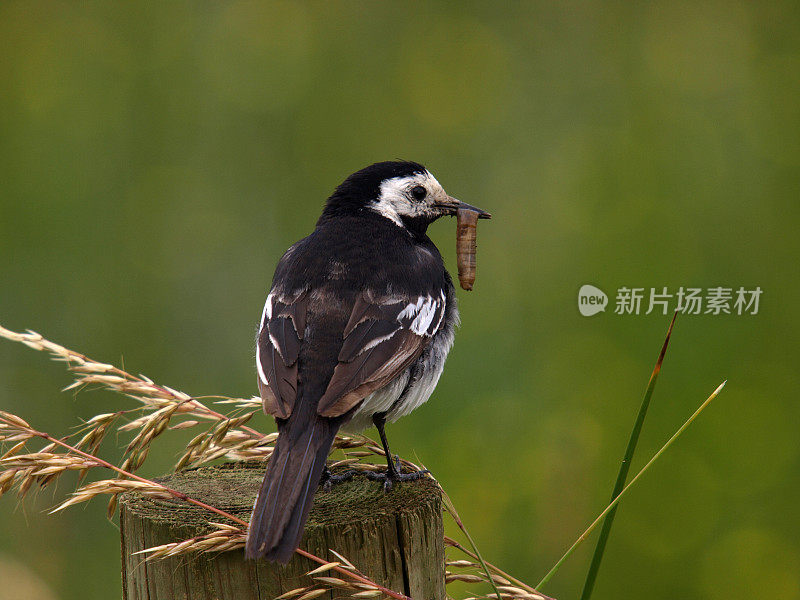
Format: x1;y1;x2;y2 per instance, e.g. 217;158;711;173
245;160;490;564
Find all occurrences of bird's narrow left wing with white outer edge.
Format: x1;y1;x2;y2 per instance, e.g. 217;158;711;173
256;290;308;419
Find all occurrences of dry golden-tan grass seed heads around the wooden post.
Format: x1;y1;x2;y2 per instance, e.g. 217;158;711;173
0;326;547;600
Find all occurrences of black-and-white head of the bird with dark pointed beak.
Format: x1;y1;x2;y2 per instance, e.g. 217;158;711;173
320;161;490;234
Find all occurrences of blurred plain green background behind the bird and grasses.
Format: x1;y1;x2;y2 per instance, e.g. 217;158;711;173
0;1;800;600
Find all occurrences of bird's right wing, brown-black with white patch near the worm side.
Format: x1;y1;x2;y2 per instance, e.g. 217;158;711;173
317;293;446;417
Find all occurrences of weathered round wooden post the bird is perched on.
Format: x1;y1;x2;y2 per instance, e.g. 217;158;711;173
120;463;445;600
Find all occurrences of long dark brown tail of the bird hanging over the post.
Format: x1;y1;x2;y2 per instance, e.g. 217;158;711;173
245;402;339;563
